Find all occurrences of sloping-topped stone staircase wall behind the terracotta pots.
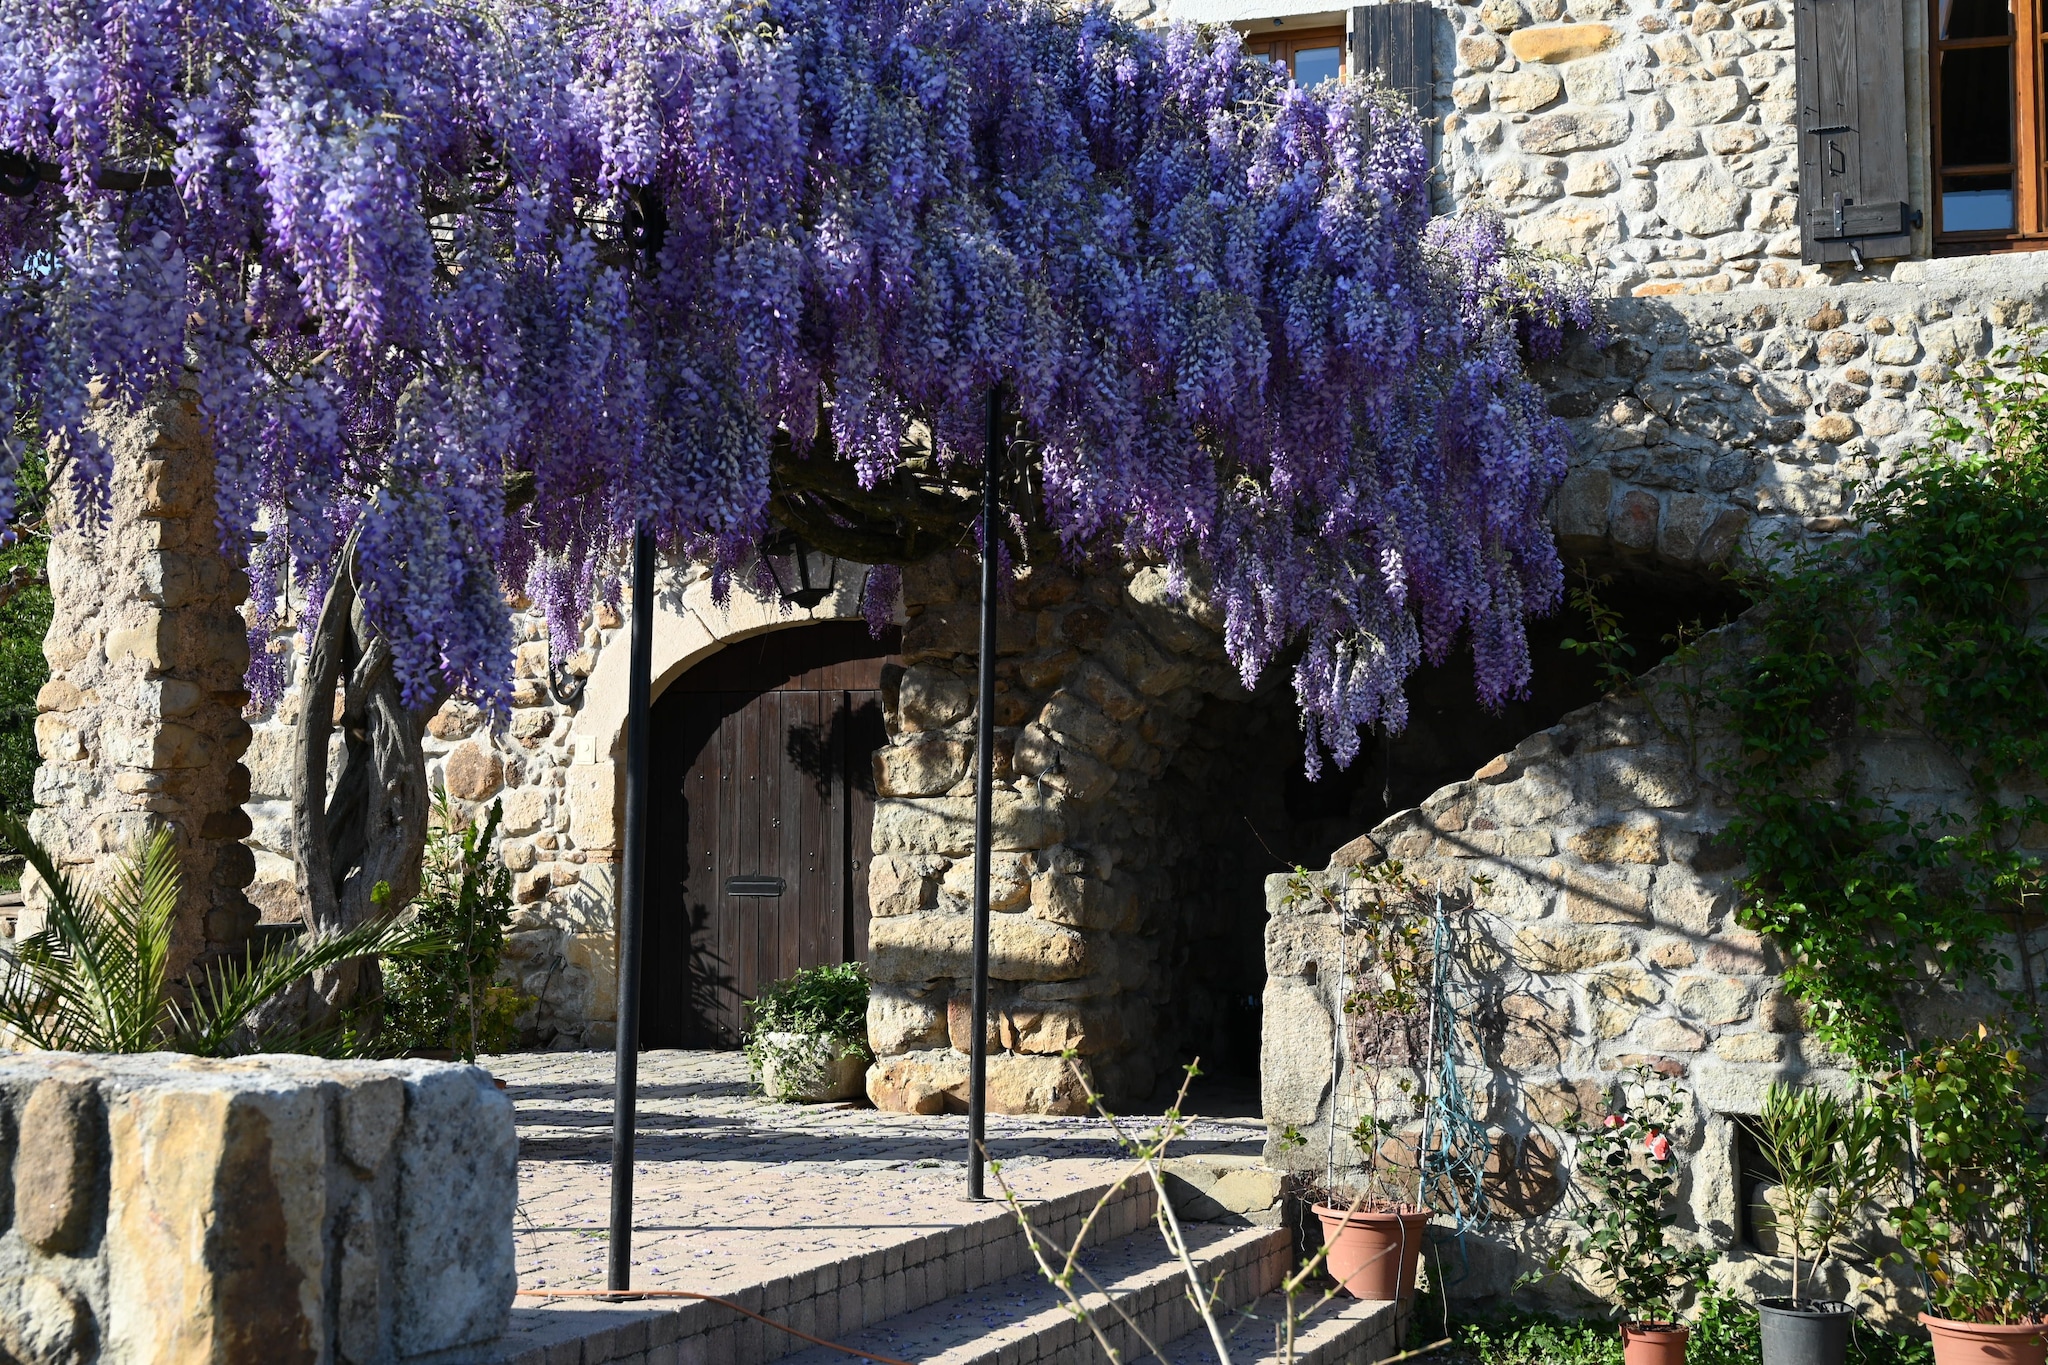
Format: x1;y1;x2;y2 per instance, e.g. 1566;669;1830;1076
1262;622;2038;1308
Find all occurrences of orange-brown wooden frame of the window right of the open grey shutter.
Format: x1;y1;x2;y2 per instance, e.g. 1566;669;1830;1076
1927;0;2048;256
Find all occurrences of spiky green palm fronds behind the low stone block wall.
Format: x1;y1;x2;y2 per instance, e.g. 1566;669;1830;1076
0;814;449;1056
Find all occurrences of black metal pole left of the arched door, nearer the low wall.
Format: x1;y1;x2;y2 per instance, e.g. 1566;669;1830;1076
604;520;653;1291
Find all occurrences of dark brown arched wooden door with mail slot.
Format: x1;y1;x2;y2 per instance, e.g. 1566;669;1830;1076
641;622;899;1048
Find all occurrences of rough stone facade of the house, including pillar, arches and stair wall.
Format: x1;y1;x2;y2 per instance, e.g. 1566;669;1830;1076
24;0;2048;1326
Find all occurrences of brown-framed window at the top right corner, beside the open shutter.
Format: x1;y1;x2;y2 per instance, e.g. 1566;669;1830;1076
1929;0;2048;254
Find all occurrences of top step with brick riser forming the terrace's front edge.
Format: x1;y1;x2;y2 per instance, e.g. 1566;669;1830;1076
471;1179;1163;1365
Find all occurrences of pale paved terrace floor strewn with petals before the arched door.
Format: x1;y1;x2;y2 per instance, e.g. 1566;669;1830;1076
483;1052;1266;1291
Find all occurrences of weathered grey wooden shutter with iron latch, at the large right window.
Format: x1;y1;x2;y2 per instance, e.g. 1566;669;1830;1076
1792;0;1919;262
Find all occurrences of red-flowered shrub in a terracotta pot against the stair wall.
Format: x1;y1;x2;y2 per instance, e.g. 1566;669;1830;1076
1567;1068;1714;1365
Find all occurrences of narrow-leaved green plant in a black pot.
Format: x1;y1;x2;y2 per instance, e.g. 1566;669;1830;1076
1755;1085;1896;1365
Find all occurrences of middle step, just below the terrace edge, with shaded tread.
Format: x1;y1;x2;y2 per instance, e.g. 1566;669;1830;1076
786;1224;1290;1365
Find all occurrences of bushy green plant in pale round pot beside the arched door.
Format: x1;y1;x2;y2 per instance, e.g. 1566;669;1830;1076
745;962;874;1103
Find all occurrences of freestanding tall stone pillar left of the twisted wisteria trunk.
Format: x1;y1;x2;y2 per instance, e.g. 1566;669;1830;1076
29;395;256;978
